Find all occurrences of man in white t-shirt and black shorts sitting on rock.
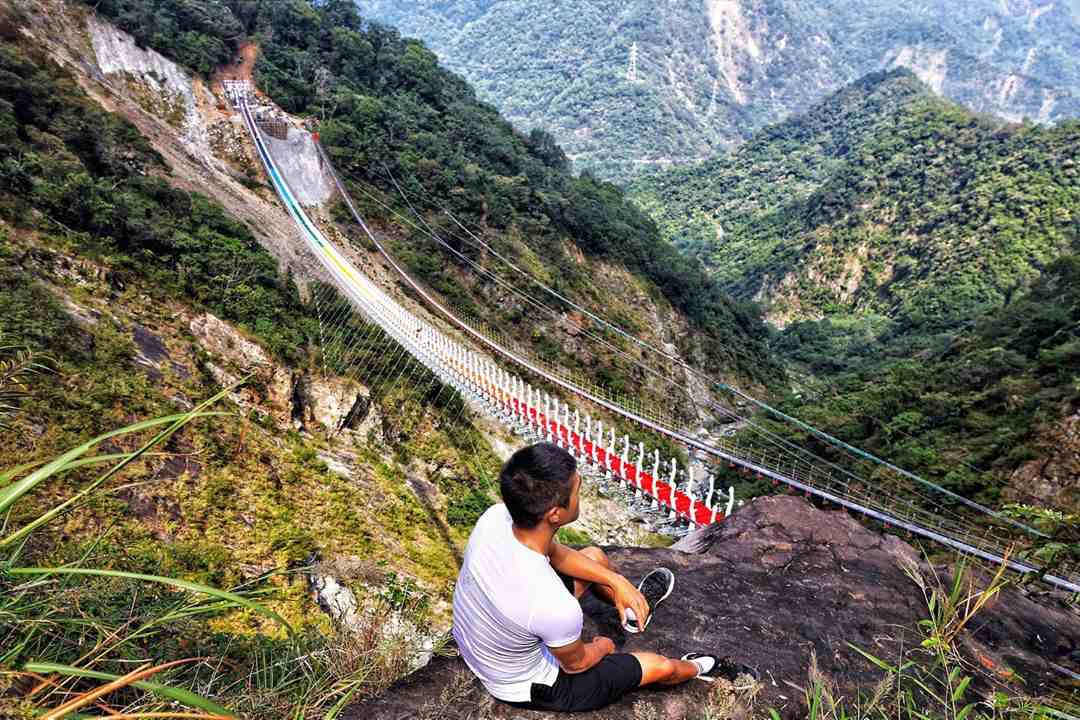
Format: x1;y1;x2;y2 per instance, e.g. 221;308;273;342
454;443;726;711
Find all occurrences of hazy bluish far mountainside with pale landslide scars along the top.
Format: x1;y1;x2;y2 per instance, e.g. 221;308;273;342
357;0;1080;180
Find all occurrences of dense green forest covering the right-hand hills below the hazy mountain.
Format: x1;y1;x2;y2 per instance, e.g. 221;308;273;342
633;70;1080;518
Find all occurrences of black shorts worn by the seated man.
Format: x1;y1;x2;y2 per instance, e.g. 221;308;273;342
510;653;642;712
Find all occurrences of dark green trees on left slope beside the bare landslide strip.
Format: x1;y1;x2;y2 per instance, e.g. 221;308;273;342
0;33;312;362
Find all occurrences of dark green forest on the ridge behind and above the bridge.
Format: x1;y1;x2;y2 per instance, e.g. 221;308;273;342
82;0;780;382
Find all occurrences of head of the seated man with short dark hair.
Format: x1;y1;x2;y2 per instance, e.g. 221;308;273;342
499;443;578;529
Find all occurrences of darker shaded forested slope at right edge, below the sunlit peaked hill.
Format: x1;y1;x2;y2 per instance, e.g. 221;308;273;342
778;248;1080;511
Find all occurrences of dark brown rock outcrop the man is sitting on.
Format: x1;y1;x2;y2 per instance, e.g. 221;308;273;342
342;498;1080;720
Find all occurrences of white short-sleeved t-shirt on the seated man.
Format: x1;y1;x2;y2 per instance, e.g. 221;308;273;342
454;503;582;703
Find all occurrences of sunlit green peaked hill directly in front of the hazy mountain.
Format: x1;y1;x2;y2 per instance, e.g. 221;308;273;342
634;71;1080;334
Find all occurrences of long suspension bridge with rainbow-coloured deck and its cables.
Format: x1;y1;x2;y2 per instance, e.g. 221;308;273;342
226;81;1080;593
